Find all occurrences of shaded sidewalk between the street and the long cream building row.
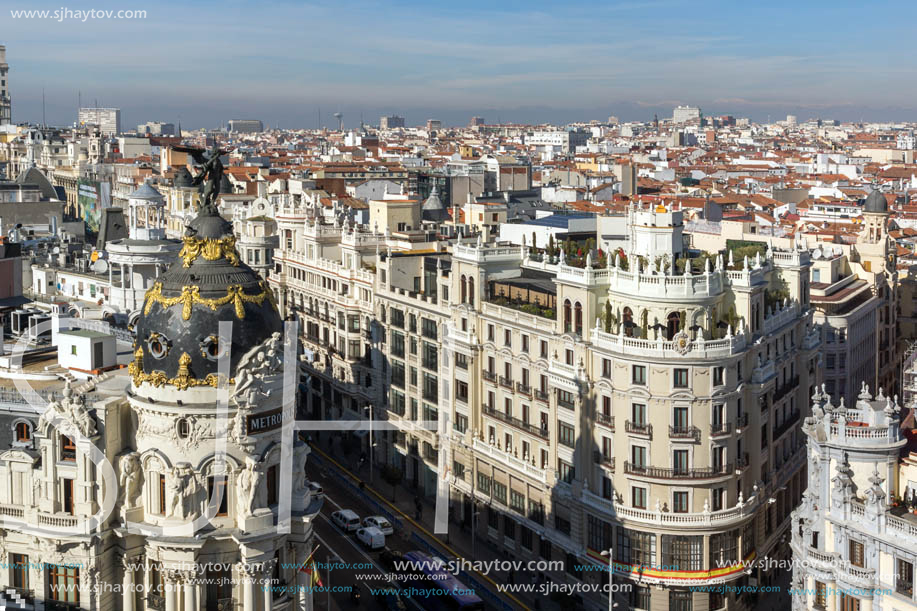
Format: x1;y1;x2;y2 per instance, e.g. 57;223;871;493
313;435;560;611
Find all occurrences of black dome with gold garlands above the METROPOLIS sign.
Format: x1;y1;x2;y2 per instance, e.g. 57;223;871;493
129;207;283;389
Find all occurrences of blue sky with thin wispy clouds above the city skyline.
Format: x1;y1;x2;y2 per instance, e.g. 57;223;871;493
0;0;917;127
